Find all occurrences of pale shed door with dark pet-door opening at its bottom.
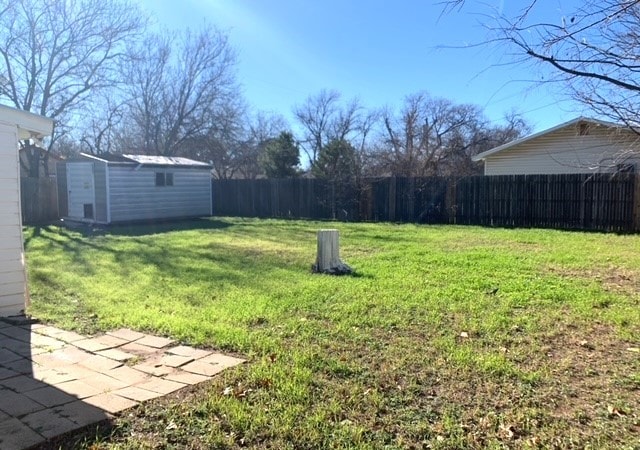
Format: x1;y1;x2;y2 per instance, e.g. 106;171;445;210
67;163;96;220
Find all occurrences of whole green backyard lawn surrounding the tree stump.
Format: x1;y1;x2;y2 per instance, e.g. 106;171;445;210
25;218;640;449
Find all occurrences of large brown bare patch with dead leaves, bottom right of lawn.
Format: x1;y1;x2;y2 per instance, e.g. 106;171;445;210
360;323;640;449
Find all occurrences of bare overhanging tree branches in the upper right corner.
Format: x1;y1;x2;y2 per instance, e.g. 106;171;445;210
445;0;640;129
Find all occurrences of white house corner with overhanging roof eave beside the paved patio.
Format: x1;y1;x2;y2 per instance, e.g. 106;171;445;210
0;105;53;316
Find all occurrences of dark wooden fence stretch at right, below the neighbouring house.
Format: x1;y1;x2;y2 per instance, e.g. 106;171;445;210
453;173;640;231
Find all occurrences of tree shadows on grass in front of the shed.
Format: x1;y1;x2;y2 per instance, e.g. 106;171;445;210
25;219;310;298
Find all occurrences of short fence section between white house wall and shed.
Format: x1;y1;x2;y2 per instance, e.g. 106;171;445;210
20;177;58;224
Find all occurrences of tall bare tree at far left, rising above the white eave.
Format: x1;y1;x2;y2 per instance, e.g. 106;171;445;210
0;0;145;177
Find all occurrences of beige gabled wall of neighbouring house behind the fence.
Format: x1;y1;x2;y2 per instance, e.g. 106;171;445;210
484;125;640;175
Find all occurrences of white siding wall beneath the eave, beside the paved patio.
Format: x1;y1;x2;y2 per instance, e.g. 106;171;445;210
0;122;26;316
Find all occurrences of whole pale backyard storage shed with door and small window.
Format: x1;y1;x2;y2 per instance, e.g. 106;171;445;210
57;154;212;224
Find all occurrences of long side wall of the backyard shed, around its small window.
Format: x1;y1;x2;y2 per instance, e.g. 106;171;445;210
109;164;211;222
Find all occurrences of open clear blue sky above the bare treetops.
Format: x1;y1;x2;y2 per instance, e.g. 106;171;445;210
139;0;581;130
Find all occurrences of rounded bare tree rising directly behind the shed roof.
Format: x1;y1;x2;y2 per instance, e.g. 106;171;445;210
130;27;240;155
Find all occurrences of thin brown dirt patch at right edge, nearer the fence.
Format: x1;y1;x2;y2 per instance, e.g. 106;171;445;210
549;266;640;294
